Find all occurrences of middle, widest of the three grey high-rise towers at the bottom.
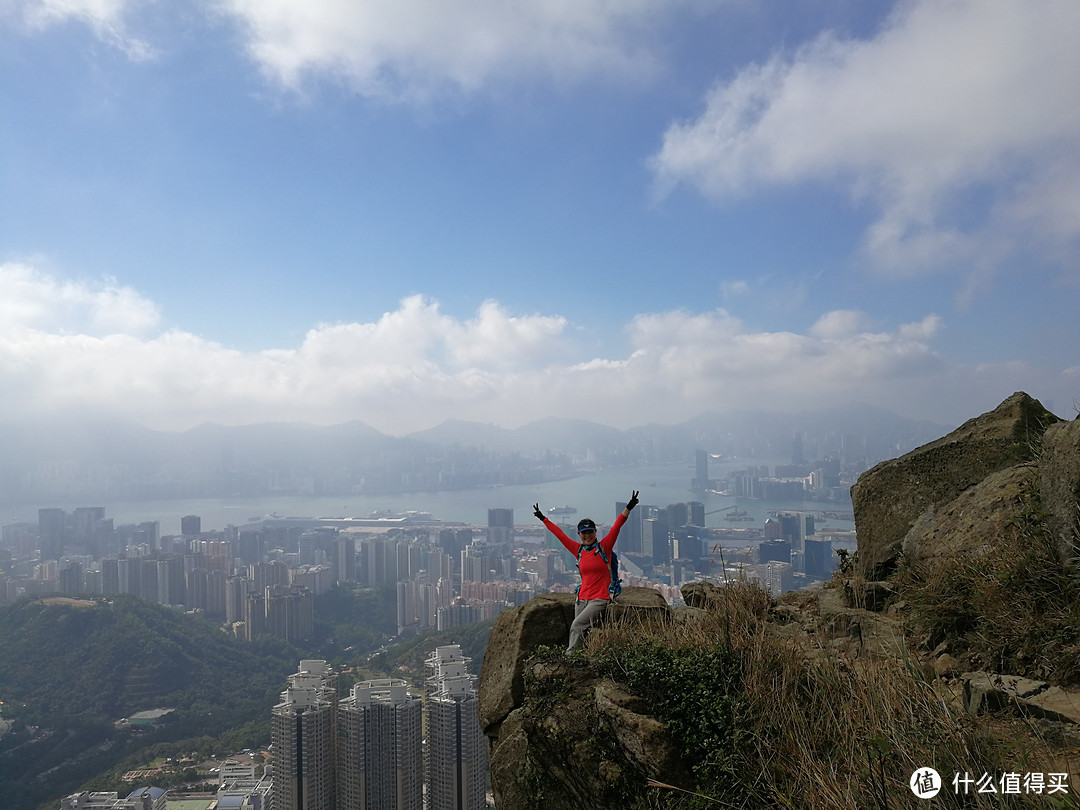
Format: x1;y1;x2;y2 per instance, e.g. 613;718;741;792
337;678;423;810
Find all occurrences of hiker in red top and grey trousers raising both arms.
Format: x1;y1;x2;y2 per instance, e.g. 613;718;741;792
532;489;637;652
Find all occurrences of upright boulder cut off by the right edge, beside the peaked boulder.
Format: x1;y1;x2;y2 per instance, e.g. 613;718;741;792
1039;419;1080;563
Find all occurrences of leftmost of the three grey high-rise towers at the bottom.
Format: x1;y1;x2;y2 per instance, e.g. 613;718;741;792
270;660;337;810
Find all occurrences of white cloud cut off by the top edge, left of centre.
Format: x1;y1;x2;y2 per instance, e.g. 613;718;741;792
222;0;669;98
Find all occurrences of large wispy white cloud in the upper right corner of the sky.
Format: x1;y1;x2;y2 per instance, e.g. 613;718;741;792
652;0;1080;282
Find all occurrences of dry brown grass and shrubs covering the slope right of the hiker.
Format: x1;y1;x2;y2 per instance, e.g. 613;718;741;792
574;582;1071;810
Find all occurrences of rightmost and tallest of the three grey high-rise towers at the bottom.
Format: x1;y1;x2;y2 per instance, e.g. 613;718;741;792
424;644;487;810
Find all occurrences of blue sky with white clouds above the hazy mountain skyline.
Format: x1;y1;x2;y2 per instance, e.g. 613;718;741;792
0;0;1080;433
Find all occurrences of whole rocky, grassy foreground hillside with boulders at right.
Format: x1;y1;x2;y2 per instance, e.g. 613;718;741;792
480;393;1080;810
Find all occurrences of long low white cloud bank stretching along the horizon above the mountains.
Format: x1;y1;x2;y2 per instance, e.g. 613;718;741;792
0;265;1062;434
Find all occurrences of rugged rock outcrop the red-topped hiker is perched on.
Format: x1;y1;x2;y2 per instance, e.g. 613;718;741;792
480;588;673;810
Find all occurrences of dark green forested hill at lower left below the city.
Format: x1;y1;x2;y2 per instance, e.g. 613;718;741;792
0;596;300;808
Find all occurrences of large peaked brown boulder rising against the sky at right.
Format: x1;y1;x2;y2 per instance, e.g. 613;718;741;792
851;392;1059;580
